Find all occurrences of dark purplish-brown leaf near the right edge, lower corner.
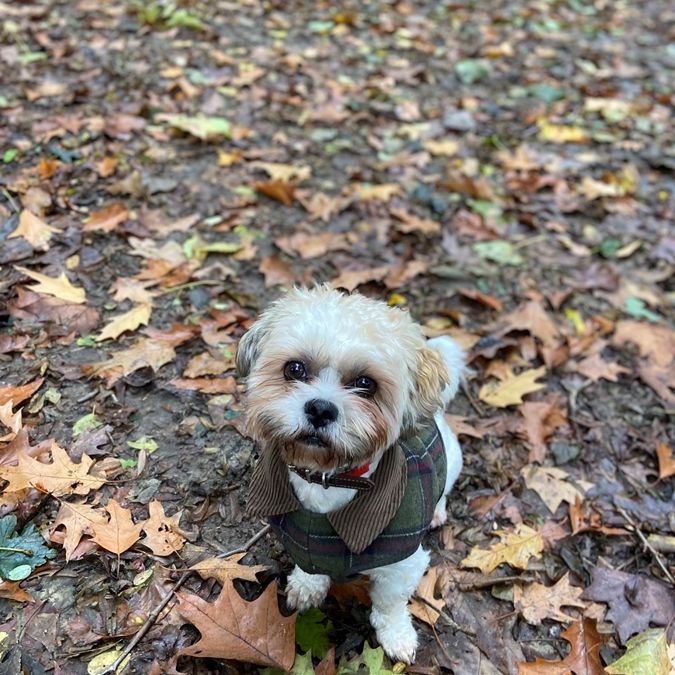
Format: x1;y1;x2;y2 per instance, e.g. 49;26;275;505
583;567;675;643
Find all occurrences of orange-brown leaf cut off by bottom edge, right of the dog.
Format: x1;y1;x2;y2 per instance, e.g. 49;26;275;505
518;619;609;675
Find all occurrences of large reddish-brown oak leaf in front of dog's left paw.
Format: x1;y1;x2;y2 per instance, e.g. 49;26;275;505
177;583;295;670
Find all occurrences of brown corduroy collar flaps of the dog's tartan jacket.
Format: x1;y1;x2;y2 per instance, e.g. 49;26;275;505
247;444;408;554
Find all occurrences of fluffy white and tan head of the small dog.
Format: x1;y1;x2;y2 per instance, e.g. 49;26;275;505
237;287;448;471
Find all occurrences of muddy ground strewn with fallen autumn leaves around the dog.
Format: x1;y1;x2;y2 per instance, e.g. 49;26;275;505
0;0;675;674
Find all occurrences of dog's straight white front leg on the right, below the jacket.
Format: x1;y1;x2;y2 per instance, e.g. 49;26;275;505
365;546;429;663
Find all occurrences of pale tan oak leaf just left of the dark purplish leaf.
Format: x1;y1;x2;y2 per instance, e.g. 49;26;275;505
513;572;586;626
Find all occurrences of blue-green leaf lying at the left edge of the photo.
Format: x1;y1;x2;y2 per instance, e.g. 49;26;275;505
0;515;56;581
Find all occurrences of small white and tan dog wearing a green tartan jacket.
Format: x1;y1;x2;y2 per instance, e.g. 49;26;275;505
237;286;464;663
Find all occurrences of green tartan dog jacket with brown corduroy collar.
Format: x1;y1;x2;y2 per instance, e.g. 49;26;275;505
249;421;447;581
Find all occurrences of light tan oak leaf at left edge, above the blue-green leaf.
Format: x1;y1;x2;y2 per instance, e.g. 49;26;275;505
0;442;105;497
